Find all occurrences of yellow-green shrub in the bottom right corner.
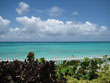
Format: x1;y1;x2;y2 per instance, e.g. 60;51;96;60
66;65;110;83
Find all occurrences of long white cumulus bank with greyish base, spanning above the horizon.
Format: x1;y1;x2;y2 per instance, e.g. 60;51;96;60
2;16;110;39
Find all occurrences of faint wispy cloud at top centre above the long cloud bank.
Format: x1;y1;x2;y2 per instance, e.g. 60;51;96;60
48;6;63;16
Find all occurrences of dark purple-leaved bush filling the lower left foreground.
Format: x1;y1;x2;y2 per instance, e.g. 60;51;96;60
0;61;61;83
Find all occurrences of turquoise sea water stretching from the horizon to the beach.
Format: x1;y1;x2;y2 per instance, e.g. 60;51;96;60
0;42;110;59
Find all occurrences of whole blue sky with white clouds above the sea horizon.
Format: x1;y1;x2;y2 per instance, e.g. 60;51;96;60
0;0;110;41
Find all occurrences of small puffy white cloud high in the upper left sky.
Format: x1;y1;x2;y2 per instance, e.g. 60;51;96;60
16;2;29;15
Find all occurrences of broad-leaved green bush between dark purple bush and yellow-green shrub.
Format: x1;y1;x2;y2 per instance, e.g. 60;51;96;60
59;57;110;80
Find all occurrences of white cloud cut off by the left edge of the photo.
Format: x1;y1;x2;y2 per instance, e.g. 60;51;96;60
0;16;10;36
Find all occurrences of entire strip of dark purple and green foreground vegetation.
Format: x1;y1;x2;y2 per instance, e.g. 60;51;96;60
0;52;110;83
